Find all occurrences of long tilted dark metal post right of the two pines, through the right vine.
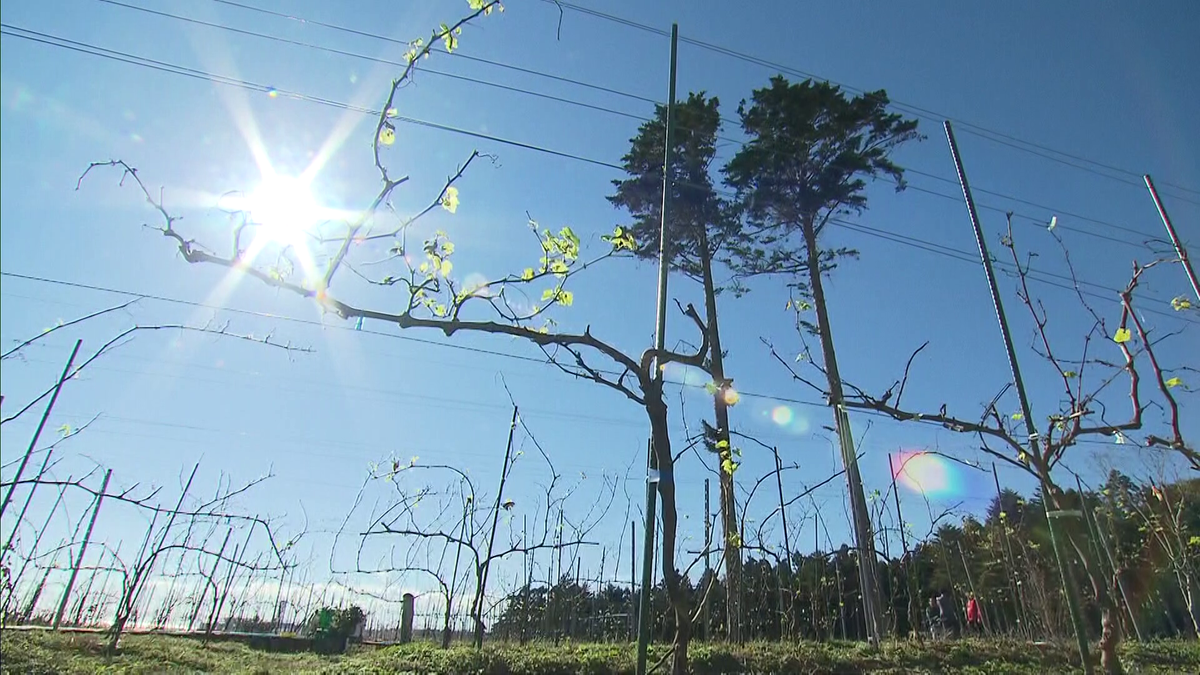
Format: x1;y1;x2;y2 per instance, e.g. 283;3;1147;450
942;120;1093;675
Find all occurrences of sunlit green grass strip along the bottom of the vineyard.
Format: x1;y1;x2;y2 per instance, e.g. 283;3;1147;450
0;631;1200;675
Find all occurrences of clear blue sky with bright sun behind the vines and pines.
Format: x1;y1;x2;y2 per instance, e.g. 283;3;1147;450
0;0;1200;612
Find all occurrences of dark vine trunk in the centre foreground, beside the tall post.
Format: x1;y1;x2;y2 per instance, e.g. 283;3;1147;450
642;384;691;675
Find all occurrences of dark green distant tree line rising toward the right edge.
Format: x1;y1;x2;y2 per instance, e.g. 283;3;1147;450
490;471;1200;641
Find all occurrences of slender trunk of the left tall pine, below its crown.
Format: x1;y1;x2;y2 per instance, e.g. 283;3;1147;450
700;228;743;643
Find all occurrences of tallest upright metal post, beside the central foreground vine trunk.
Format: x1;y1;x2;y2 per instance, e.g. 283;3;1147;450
637;24;679;675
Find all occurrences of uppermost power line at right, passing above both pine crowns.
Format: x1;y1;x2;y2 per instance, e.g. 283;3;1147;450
542;0;1200;203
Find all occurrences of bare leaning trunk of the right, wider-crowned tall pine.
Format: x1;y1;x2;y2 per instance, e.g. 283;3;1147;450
800;216;881;644
